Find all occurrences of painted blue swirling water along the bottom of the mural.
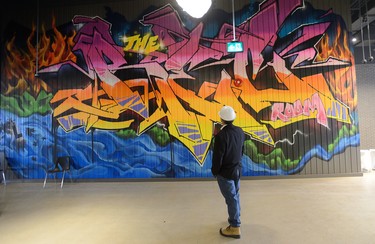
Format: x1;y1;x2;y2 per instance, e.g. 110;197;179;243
0;111;359;179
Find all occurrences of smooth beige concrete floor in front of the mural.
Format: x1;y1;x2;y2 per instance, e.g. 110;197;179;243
0;173;375;244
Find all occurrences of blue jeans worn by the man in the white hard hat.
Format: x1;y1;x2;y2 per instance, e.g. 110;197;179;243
216;175;241;227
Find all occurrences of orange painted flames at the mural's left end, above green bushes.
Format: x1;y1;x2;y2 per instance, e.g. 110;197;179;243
4;17;76;96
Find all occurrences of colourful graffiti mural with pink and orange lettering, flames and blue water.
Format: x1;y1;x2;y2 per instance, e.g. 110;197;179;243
1;0;359;178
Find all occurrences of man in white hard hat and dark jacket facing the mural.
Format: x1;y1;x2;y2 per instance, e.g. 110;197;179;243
211;106;245;239
